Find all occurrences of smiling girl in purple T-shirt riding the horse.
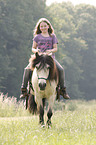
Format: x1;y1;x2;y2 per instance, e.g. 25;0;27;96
20;18;70;99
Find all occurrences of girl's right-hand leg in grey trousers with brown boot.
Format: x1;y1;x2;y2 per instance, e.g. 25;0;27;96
55;59;70;99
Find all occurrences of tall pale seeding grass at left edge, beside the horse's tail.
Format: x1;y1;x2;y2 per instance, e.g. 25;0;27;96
0;93;29;117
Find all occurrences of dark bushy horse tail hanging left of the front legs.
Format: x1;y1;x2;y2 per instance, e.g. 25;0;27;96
28;94;37;114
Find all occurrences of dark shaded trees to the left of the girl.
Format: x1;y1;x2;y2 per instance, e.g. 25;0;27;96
0;0;45;98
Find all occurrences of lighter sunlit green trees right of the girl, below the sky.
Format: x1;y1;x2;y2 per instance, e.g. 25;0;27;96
47;2;96;99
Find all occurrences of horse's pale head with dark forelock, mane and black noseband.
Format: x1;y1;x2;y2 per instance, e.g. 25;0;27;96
32;53;57;90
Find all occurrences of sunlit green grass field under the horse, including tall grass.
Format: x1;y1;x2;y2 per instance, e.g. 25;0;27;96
0;94;96;145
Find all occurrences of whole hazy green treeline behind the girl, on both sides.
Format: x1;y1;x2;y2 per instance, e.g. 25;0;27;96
0;0;96;100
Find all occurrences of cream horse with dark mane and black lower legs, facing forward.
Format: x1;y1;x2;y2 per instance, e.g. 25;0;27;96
28;53;59;127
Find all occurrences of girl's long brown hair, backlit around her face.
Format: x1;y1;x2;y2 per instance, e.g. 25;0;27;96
34;18;54;36
